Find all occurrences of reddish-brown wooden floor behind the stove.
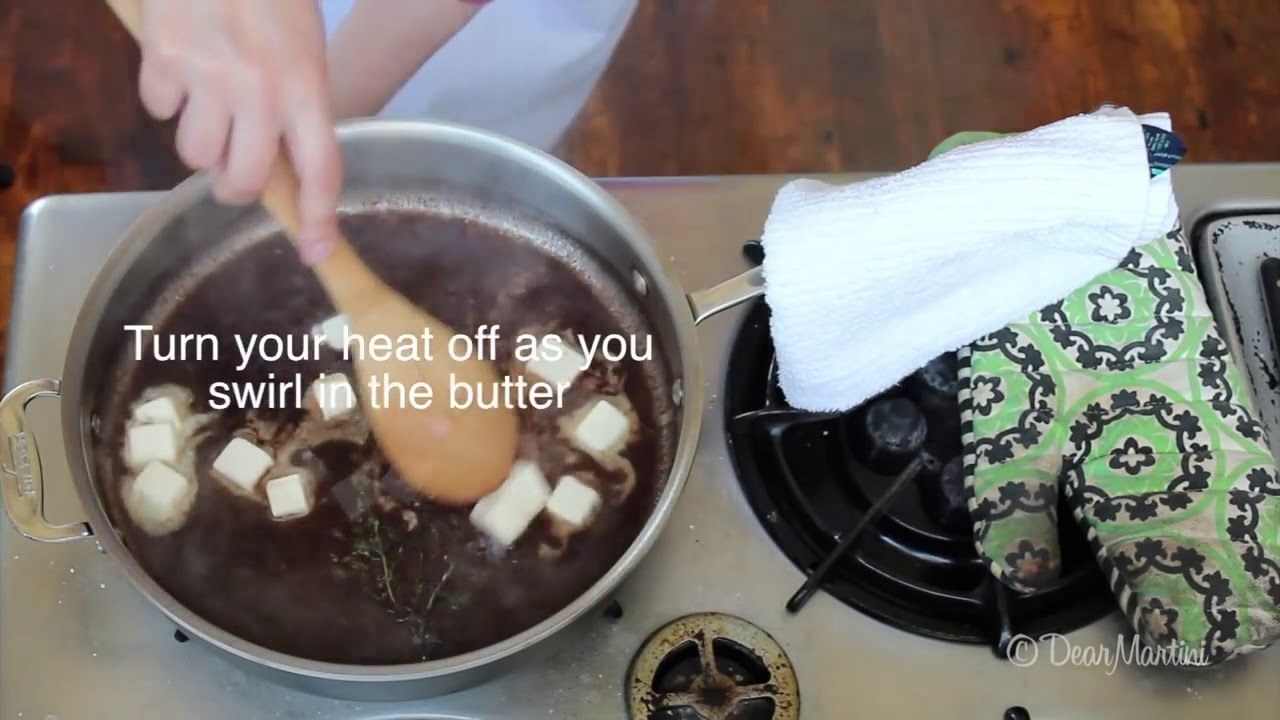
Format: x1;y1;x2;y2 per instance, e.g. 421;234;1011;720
0;0;1280;366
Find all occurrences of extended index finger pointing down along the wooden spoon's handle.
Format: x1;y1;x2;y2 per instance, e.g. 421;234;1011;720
285;92;342;264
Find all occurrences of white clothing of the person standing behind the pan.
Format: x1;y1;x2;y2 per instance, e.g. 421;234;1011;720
320;0;637;150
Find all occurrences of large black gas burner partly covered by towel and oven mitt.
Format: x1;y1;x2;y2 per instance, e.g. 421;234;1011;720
724;294;1116;648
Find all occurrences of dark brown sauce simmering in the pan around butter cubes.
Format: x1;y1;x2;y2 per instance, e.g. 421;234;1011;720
96;206;671;665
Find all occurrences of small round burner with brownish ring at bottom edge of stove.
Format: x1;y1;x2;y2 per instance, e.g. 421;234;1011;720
627;612;800;720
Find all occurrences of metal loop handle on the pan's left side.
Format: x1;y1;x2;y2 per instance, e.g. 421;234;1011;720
0;379;93;542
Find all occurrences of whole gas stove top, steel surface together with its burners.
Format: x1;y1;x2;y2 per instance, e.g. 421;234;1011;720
0;165;1280;720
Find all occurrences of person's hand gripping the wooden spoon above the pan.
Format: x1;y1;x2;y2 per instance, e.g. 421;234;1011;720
138;0;342;263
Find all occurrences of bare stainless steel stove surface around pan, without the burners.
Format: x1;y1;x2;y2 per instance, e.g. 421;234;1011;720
0;165;1280;720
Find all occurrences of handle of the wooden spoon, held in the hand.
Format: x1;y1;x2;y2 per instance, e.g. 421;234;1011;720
106;0;389;314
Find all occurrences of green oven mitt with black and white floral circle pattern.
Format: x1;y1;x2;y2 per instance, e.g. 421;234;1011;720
934;133;1280;665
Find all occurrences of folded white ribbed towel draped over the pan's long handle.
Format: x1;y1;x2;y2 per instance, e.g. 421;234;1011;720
762;108;1178;411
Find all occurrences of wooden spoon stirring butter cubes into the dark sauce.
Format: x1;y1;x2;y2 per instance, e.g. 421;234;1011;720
106;0;520;505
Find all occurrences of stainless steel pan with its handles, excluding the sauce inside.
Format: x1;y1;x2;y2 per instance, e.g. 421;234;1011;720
0;120;763;700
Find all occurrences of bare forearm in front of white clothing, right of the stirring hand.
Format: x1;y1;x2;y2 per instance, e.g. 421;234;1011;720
329;0;483;119
